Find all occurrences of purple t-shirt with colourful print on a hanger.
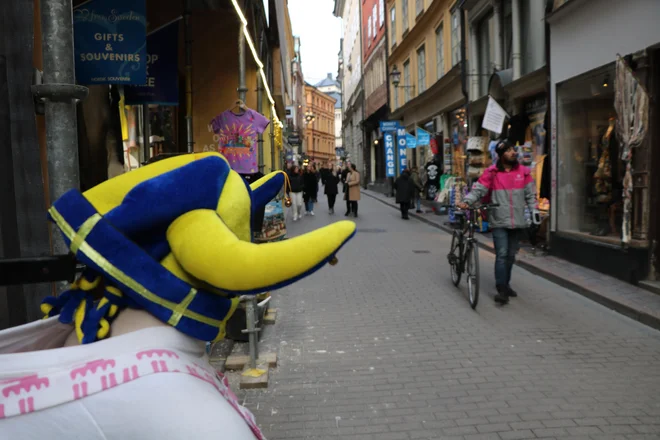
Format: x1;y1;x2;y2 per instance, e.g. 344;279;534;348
211;109;270;174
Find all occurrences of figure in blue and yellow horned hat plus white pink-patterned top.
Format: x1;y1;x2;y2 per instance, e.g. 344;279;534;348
0;153;355;439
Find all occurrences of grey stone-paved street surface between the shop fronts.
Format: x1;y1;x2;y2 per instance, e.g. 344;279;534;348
234;192;660;440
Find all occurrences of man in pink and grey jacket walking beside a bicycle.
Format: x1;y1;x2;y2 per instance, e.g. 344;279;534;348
458;140;538;304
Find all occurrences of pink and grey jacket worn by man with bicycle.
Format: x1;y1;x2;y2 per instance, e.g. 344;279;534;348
464;165;536;229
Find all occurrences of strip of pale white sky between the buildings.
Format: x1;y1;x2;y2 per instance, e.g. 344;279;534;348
289;0;341;84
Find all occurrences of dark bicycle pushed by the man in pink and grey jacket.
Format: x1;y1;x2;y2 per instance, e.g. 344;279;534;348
447;204;499;310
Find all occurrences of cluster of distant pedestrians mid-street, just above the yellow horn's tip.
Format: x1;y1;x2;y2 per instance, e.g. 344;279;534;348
287;164;360;222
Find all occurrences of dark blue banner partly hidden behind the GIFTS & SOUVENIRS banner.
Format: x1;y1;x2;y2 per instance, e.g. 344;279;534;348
124;18;179;105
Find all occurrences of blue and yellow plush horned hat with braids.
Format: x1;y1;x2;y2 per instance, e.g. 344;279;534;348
42;153;355;344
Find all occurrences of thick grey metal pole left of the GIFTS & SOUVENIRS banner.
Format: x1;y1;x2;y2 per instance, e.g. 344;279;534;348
32;0;88;255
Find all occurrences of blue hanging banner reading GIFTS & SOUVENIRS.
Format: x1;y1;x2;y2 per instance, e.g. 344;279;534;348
73;0;147;85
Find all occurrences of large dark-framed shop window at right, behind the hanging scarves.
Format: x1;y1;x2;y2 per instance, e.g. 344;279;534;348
556;65;624;237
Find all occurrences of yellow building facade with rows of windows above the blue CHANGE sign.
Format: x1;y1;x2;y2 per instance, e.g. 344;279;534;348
386;0;465;166
